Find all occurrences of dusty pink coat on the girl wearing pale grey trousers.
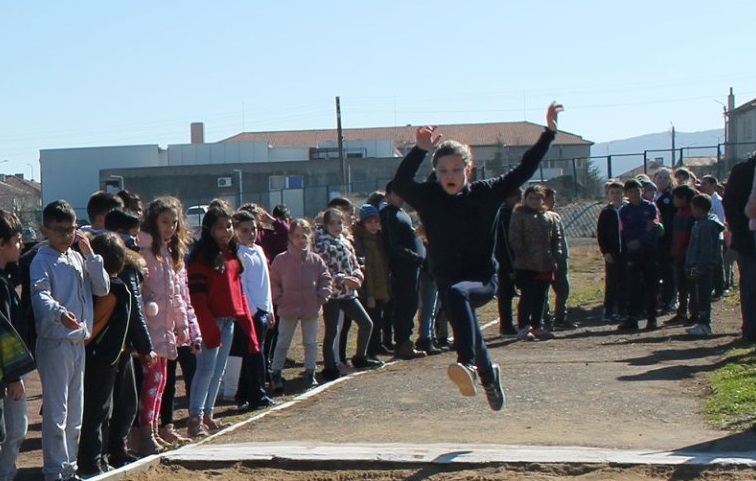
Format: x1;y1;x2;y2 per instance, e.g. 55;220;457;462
270;245;331;319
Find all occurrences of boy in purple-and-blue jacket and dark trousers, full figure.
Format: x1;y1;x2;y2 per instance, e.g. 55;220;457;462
618;179;663;331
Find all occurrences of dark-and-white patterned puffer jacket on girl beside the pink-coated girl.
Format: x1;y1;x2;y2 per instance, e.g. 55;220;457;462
313;232;365;299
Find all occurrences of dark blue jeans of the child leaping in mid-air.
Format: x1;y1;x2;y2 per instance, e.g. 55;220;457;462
438;274;496;384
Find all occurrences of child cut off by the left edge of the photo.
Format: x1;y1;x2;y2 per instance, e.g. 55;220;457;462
0;210;34;481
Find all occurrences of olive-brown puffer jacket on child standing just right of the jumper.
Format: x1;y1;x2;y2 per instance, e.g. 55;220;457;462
509;205;562;272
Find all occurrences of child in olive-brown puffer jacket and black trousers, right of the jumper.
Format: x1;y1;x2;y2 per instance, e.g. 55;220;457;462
509;185;562;341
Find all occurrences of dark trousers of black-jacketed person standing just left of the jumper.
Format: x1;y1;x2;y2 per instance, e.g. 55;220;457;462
391;264;420;346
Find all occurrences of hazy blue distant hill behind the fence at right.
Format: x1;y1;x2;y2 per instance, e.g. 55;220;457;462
591;129;724;176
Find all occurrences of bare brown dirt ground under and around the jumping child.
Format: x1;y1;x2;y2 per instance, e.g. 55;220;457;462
11;243;756;481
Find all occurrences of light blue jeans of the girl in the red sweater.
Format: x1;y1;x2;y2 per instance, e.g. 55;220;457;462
189;317;235;417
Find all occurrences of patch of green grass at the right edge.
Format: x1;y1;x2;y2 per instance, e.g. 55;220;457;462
704;348;756;430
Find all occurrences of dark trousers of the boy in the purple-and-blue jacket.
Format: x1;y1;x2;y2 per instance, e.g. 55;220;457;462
625;250;659;320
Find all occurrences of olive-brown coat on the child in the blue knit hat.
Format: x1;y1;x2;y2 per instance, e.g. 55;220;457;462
352;222;391;301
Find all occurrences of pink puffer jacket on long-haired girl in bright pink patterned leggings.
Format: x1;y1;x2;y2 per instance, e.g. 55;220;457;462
137;232;200;360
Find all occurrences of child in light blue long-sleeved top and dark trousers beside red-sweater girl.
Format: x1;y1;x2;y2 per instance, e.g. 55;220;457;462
232;210;278;409
